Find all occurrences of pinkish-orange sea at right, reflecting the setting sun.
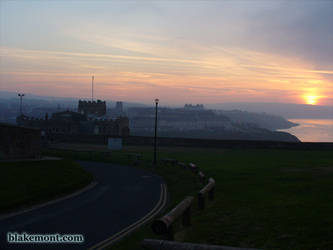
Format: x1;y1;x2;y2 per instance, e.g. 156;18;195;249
279;119;333;142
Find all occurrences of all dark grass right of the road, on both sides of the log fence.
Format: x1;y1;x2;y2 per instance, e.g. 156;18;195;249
44;147;333;249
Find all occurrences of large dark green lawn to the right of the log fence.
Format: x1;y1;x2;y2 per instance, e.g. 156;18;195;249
185;150;333;249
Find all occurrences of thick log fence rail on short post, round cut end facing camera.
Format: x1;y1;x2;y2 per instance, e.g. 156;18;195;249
152;196;194;240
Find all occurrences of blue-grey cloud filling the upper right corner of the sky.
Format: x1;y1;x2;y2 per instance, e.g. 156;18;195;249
240;1;333;70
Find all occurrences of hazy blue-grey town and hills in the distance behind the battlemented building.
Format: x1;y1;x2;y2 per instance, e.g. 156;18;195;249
0;89;332;141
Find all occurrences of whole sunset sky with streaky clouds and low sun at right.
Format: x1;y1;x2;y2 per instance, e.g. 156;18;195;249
0;0;333;105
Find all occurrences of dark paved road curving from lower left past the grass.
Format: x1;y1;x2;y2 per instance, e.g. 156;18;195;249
0;161;162;249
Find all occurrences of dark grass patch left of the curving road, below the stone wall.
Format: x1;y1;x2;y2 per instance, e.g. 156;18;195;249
0;160;93;213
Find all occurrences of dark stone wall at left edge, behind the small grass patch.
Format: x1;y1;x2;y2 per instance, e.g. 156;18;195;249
0;123;41;160
